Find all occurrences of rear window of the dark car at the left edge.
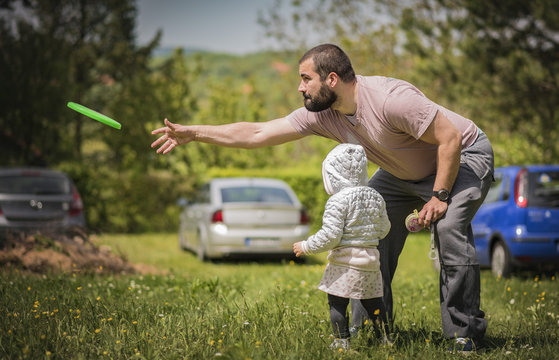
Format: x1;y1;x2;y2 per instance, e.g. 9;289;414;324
0;175;71;195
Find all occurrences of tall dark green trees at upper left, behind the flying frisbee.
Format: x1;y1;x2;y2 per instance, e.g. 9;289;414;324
0;0;159;165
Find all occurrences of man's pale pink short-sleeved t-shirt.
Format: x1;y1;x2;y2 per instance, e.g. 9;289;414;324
287;75;478;180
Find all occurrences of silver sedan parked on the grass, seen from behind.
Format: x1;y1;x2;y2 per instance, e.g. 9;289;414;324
179;178;309;260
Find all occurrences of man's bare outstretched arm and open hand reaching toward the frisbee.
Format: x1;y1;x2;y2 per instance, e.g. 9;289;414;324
151;118;304;154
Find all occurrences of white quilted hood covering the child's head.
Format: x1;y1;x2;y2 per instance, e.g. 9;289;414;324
322;144;368;195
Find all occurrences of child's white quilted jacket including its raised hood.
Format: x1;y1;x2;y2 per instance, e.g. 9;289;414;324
302;144;390;254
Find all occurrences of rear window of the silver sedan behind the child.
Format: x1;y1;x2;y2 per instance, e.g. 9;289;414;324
221;186;293;204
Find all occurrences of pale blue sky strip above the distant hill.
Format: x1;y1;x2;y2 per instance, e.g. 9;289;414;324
136;0;280;55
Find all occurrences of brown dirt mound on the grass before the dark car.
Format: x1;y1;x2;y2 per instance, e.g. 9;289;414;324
0;229;160;274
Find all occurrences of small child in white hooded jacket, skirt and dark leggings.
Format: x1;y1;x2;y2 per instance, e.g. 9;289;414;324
293;144;390;349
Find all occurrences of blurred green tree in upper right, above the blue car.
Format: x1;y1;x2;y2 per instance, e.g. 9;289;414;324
394;0;559;163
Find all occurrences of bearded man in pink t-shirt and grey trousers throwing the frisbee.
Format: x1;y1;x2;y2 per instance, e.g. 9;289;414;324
152;44;493;351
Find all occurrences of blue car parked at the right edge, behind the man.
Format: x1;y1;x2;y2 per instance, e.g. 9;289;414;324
472;165;559;277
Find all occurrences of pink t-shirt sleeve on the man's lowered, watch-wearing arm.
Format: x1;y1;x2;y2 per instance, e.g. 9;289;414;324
383;82;439;139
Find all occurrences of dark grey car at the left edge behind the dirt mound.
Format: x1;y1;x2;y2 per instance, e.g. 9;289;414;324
0;168;85;235
